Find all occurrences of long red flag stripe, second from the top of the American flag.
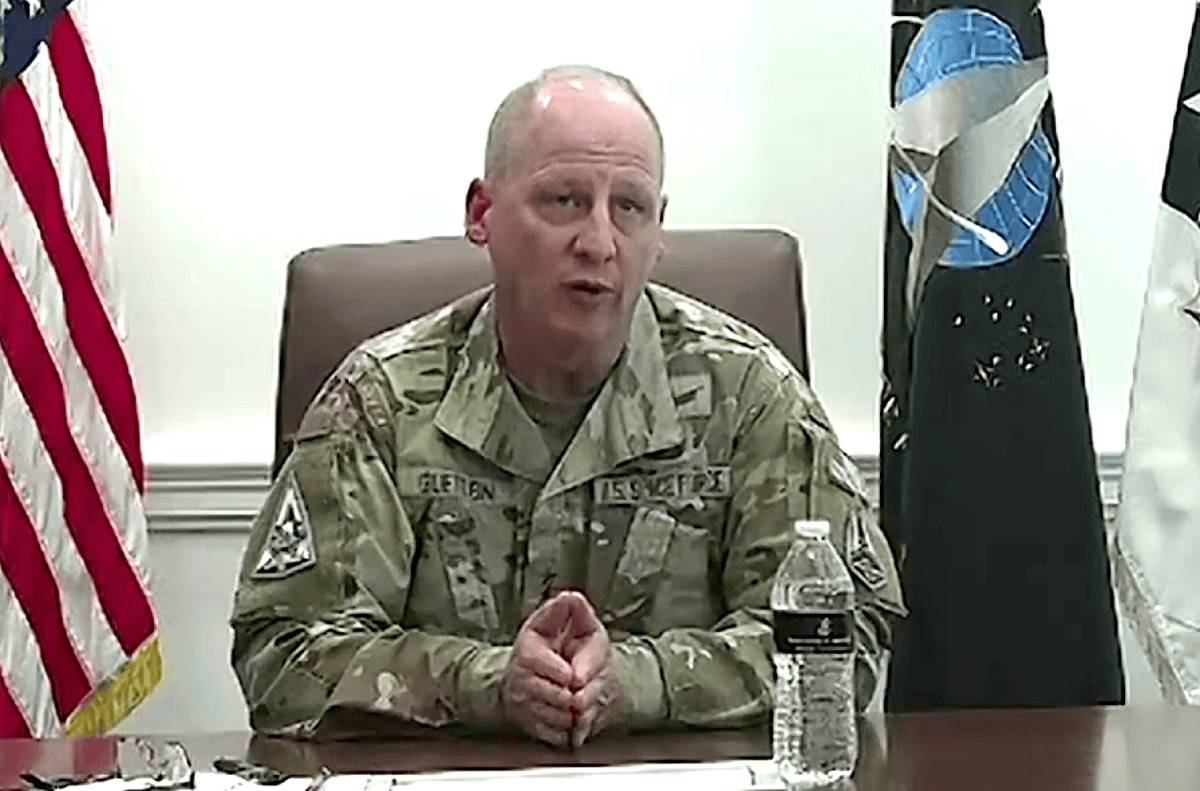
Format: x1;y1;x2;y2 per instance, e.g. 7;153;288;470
0;82;145;493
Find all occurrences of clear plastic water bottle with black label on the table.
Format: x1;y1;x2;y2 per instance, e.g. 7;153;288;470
770;521;858;789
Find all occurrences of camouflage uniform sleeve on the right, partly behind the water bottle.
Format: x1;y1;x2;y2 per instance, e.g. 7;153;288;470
617;361;905;727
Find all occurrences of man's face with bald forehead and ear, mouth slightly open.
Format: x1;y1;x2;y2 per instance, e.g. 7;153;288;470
468;79;662;348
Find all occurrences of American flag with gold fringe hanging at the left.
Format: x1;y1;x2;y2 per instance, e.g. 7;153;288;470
0;0;161;738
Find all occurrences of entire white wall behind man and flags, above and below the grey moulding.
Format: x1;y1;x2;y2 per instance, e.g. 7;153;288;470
77;0;1194;731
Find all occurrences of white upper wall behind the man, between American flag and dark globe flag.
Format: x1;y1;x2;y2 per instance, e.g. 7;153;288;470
90;0;902;463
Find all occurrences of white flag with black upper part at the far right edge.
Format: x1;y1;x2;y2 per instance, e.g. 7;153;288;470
1114;4;1200;703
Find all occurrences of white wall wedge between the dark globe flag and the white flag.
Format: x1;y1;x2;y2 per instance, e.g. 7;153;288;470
1042;0;1196;453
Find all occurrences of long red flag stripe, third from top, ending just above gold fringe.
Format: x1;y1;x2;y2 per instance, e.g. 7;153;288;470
0;250;155;655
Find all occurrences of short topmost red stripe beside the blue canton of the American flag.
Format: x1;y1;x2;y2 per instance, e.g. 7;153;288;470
49;13;113;217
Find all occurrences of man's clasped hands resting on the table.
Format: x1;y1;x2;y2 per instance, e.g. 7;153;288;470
500;591;622;748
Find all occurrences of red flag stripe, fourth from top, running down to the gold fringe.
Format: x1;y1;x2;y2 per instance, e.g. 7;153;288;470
0;463;91;721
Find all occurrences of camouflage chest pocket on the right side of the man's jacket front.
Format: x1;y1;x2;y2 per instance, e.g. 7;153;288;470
604;505;715;634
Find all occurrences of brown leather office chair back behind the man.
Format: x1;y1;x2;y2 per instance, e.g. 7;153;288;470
271;229;809;477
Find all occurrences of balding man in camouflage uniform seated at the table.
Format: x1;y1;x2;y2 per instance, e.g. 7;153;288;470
233;67;902;745
